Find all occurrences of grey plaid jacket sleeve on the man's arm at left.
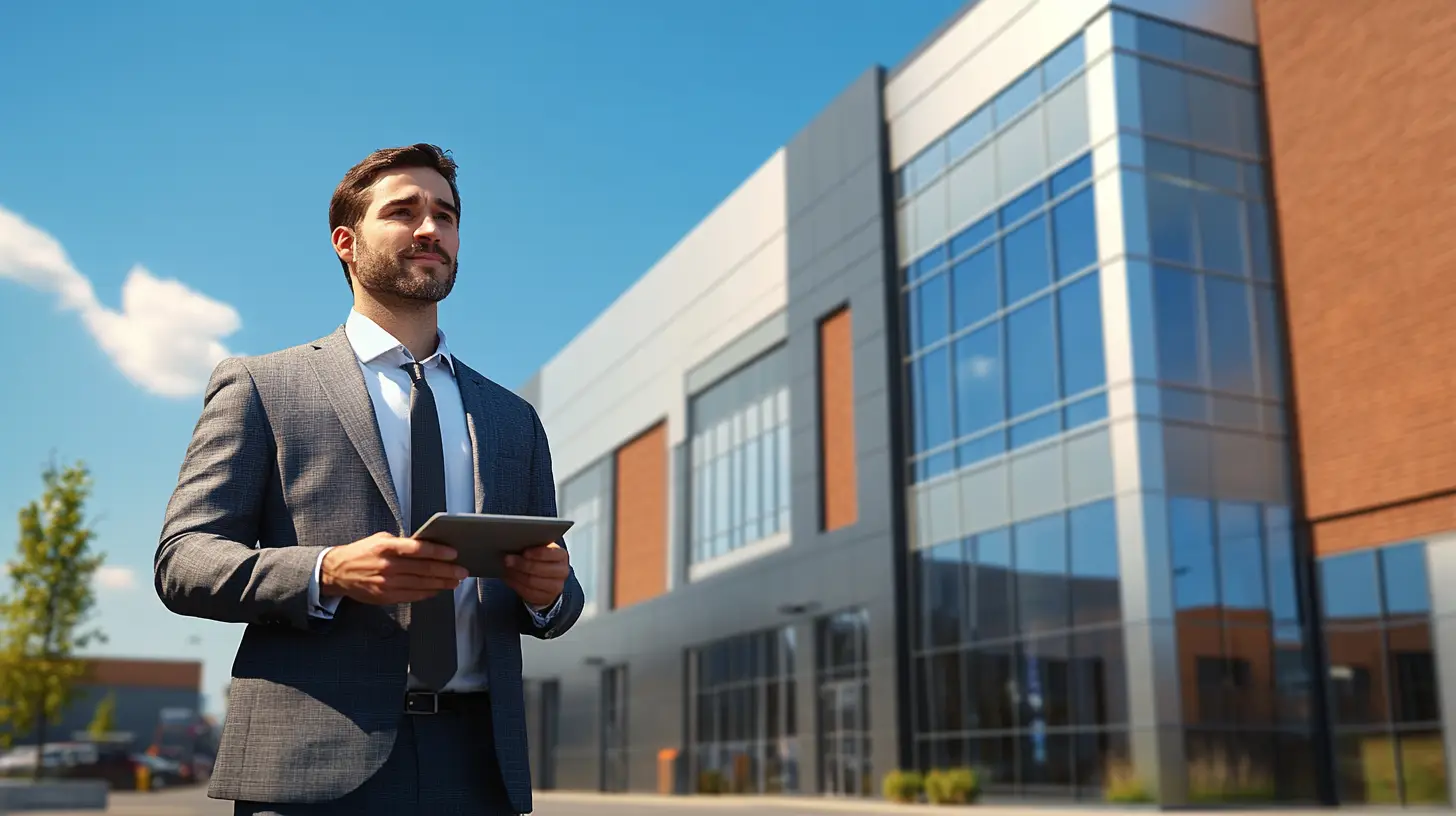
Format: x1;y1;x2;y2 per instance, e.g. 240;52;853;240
153;358;328;631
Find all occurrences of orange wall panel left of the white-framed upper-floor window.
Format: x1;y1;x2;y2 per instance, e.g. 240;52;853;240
612;423;667;609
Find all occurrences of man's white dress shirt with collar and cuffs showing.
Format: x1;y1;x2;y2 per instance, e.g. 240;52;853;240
309;309;561;691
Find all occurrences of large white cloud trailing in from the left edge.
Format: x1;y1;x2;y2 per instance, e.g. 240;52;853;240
0;207;242;396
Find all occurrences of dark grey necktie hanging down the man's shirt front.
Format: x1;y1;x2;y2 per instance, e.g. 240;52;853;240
403;363;459;691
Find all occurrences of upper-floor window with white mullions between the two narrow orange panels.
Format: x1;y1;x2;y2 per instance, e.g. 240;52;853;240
689;347;789;564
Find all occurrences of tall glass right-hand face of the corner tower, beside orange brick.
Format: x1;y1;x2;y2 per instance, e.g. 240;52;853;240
1114;12;1318;803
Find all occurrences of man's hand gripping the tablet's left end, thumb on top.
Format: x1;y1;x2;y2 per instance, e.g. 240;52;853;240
319;533;466;605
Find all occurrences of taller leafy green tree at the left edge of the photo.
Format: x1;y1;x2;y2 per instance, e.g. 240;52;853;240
0;463;105;777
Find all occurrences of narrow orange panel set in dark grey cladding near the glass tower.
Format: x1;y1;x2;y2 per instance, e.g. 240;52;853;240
818;307;859;532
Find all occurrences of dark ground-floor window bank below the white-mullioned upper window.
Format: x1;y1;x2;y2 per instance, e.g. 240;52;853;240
689;627;799;794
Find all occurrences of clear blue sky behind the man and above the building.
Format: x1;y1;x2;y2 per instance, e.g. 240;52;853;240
0;0;962;708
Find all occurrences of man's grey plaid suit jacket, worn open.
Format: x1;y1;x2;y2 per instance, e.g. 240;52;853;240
154;326;584;813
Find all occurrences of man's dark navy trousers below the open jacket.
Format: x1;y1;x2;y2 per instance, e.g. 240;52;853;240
233;695;517;816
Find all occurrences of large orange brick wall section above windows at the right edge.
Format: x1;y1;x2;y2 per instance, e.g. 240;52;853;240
1255;0;1456;552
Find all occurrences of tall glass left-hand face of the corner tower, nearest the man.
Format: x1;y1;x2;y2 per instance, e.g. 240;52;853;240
897;23;1128;799
